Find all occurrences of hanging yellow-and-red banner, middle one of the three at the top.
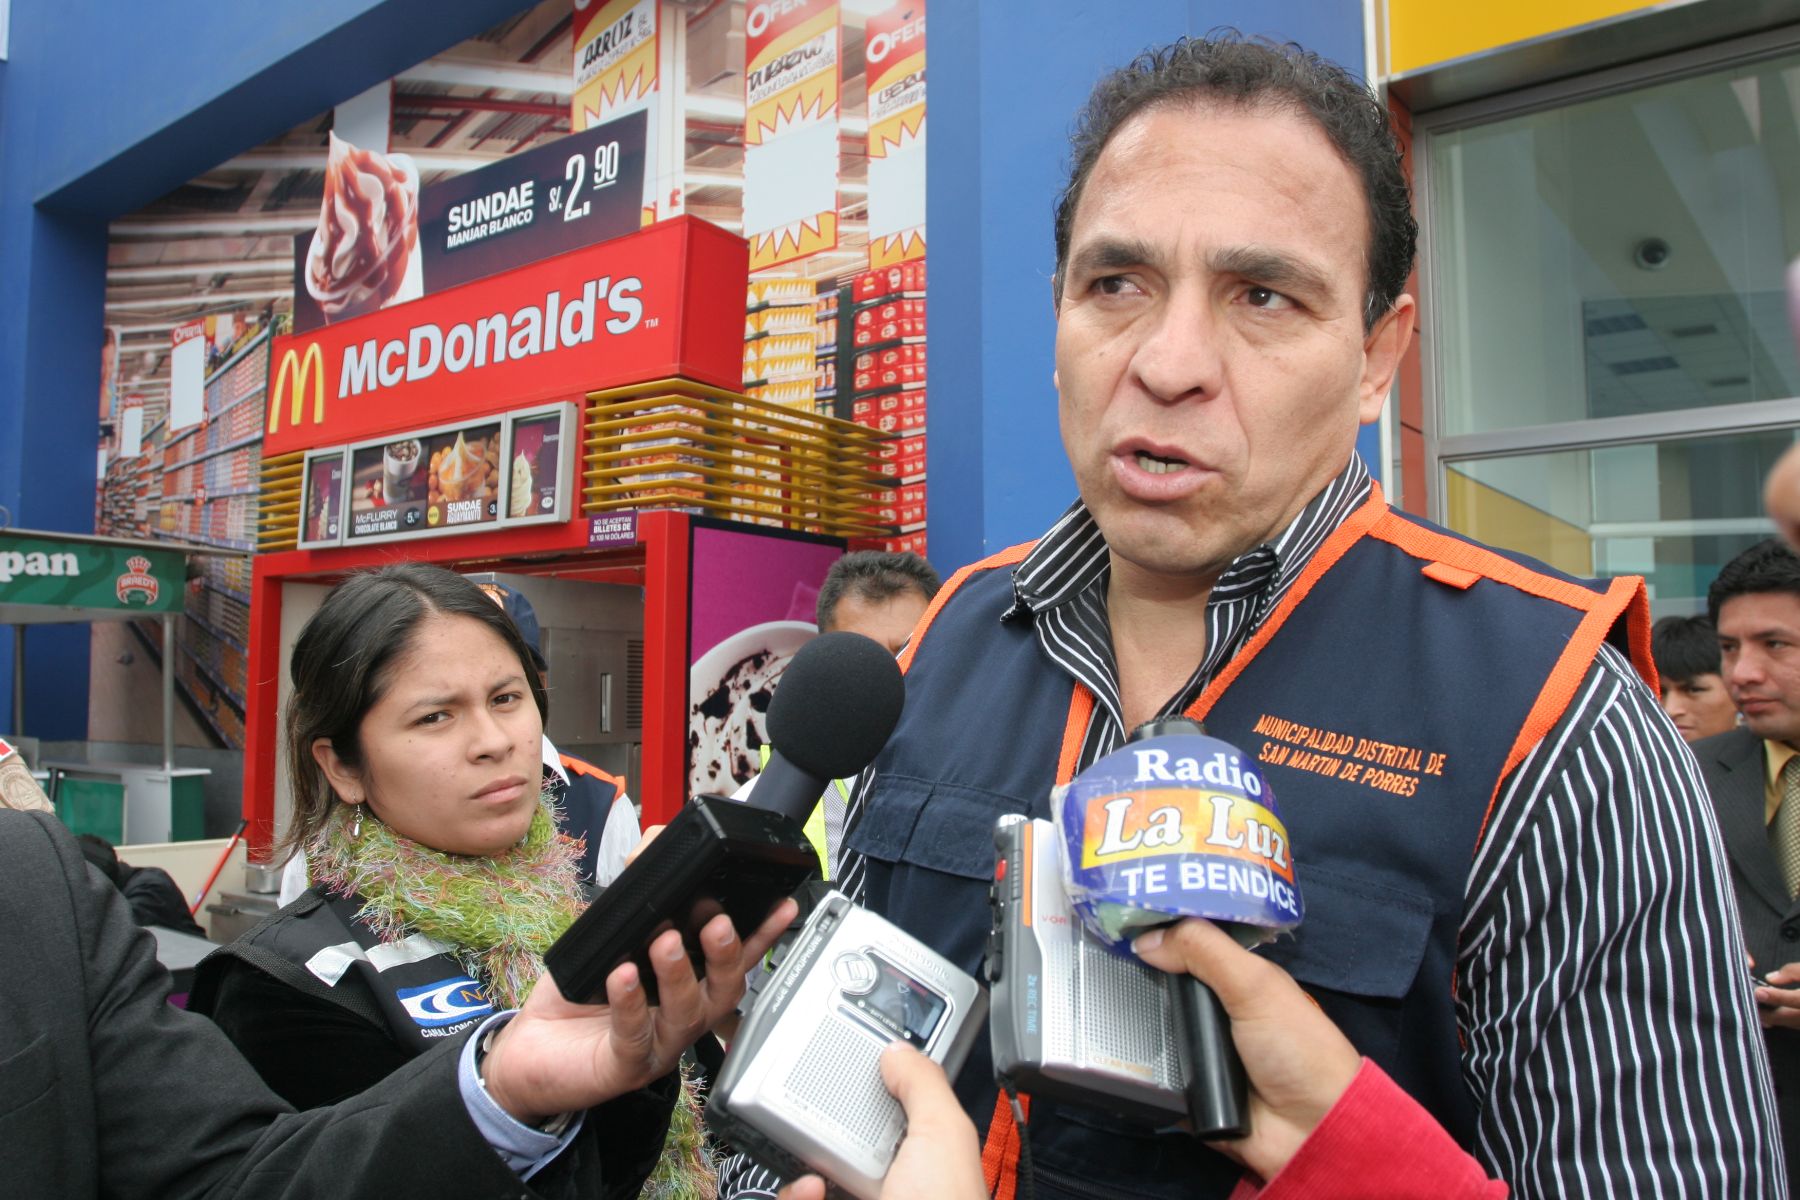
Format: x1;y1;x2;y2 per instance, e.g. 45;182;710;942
743;0;841;272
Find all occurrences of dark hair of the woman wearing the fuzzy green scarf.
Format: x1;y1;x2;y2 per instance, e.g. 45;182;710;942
277;563;549;858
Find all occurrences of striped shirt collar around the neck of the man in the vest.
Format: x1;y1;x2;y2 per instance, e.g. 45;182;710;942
1001;453;1372;621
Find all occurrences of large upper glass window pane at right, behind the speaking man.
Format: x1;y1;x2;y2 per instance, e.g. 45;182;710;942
1426;58;1800;435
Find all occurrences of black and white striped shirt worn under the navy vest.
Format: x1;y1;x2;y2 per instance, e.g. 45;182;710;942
720;459;1800;1198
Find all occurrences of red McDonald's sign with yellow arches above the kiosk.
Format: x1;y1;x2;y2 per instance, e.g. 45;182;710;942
263;218;745;457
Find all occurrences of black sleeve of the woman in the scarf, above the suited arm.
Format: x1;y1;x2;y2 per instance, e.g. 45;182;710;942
202;959;412;1108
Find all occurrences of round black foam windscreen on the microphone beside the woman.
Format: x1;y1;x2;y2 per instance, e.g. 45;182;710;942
769;631;905;781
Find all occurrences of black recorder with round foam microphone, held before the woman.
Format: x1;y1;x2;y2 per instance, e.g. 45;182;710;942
544;633;905;1004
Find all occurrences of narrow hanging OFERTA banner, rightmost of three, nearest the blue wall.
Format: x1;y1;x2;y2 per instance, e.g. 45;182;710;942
864;0;925;268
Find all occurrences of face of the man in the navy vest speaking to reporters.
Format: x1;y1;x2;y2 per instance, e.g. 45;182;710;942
1057;104;1413;585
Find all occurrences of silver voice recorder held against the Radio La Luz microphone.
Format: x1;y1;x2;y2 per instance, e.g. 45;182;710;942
985;815;1188;1124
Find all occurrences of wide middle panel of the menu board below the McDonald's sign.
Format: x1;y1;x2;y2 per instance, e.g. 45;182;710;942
349;421;502;540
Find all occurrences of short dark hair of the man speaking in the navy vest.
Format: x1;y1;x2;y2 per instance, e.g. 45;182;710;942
1055;29;1418;329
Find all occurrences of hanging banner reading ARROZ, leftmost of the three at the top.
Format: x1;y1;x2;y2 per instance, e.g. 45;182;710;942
569;0;670;225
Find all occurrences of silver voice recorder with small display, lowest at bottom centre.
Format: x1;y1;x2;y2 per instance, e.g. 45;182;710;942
706;892;988;1200
